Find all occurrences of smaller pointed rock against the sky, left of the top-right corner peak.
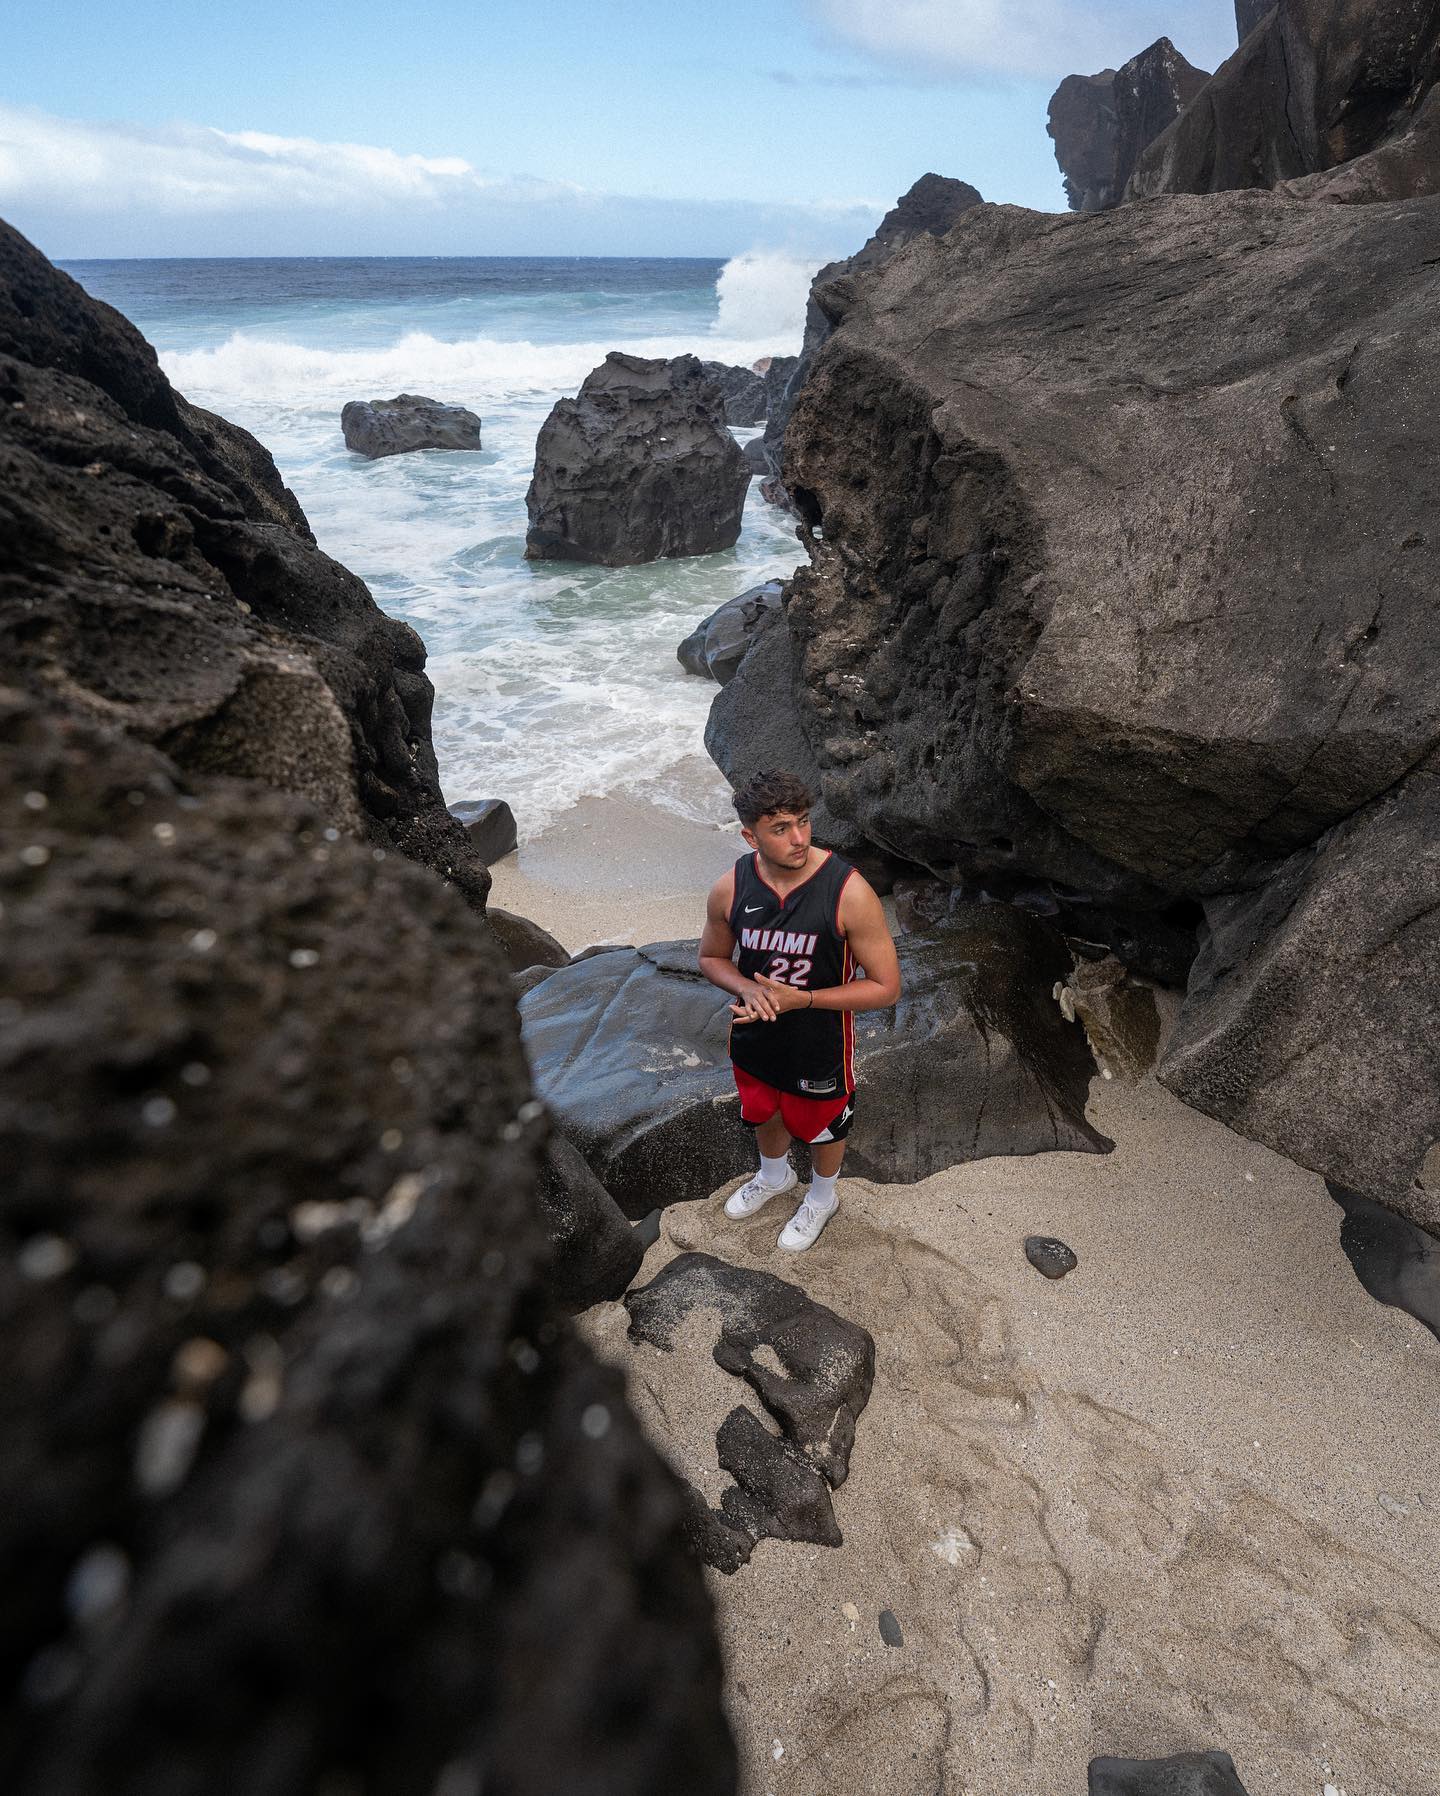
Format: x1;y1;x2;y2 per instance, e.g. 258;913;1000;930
1047;38;1210;212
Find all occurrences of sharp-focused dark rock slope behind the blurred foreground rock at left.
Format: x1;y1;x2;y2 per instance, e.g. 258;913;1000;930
0;225;490;907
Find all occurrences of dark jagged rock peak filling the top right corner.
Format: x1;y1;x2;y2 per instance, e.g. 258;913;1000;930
1126;0;1440;198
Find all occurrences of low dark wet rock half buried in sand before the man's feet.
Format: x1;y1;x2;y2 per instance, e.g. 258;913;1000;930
625;1254;874;1572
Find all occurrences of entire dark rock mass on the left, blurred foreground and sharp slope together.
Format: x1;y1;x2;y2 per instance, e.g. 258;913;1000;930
0;220;734;1796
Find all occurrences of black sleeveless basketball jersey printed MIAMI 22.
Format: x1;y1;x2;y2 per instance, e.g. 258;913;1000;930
729;855;855;1097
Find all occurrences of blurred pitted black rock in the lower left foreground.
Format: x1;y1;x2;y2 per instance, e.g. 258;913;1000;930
0;690;733;1796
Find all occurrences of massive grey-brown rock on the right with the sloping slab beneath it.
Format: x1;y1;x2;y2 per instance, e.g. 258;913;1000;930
750;194;1440;1223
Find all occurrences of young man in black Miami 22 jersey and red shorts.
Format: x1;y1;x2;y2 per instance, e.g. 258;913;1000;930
700;772;900;1254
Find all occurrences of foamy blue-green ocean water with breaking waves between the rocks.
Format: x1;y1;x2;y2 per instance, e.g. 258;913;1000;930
65;255;810;839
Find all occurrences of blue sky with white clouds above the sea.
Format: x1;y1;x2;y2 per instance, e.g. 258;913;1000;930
0;0;1235;259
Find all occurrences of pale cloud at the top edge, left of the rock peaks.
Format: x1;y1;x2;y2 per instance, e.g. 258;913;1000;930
810;0;1235;79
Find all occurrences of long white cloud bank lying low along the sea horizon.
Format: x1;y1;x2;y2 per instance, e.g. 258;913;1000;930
0;102;883;262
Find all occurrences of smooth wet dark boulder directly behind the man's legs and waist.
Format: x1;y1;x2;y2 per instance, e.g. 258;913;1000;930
519;905;1110;1218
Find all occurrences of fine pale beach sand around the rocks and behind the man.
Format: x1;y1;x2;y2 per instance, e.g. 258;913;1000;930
527;806;1440;1796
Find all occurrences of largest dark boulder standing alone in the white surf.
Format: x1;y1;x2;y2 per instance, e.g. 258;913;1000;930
524;350;751;568
